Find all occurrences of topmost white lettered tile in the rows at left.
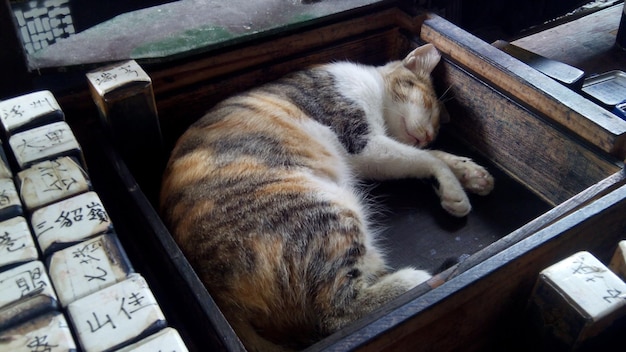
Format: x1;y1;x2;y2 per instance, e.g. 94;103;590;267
0;90;64;134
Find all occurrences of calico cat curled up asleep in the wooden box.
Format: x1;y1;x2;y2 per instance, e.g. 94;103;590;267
161;44;494;350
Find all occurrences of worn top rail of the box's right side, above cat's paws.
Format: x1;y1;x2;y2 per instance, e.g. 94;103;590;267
420;15;626;160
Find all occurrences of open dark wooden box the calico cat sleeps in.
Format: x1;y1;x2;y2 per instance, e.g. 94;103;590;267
60;6;626;351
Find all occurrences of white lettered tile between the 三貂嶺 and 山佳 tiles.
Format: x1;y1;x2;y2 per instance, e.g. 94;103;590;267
48;234;132;307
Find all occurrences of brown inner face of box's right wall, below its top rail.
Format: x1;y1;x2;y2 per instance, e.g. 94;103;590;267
435;59;621;205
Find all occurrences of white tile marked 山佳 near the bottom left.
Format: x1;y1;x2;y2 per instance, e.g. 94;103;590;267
67;274;166;352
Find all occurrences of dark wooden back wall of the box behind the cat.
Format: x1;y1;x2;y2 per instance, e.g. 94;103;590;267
55;7;416;138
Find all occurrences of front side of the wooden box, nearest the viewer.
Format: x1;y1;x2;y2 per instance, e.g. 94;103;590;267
309;186;626;351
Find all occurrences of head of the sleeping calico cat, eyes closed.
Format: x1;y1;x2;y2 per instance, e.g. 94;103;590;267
381;44;447;148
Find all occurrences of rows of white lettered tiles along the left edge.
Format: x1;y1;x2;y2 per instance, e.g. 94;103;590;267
0;91;187;352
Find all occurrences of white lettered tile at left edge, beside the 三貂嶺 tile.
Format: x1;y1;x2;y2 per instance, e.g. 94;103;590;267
0;216;39;268
